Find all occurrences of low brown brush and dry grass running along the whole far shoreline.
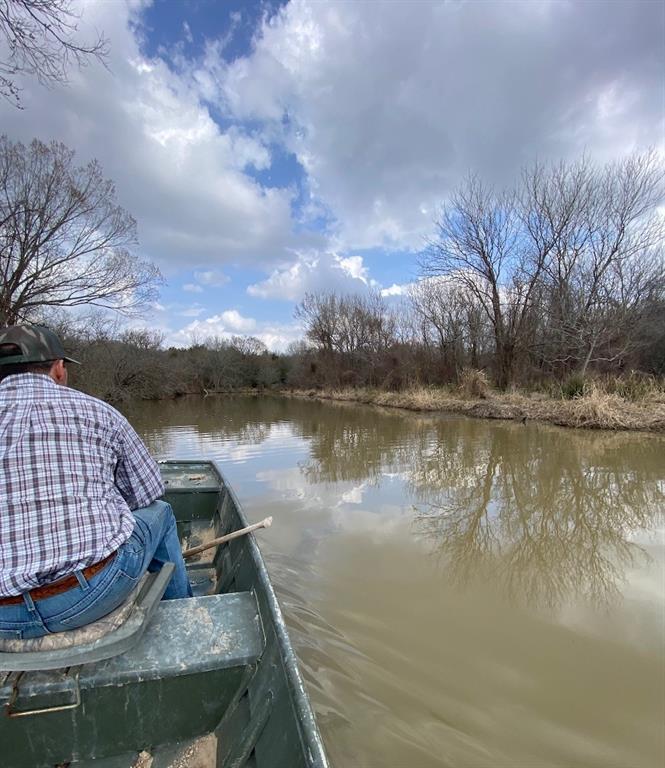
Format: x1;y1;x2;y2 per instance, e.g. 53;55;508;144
49;326;665;434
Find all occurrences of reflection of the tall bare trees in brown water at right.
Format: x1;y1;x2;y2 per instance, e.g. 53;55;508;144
410;423;664;608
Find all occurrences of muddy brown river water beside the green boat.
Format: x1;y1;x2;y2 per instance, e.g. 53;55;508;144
126;397;665;768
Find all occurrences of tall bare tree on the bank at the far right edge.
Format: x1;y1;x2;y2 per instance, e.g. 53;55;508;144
527;151;665;374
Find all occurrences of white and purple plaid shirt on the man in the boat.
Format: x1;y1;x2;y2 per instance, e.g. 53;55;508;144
0;373;164;597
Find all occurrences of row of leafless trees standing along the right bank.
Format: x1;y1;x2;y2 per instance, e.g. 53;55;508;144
297;152;665;396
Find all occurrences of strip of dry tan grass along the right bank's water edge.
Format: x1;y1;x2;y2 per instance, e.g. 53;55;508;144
285;382;665;432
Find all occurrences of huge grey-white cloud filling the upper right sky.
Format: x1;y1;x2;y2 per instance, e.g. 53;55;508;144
214;0;665;249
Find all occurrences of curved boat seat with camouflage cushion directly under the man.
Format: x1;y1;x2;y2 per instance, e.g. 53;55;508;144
0;563;175;672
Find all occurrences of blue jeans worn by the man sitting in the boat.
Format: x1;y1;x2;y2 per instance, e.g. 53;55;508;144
0;501;192;639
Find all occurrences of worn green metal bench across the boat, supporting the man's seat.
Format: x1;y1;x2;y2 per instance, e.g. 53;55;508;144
0;592;266;768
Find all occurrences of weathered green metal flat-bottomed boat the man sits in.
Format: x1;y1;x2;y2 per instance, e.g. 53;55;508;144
0;461;329;768
